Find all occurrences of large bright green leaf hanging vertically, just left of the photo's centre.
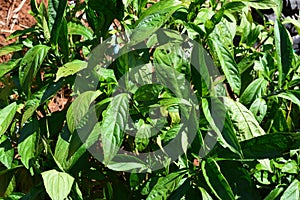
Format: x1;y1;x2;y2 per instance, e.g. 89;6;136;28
101;93;129;164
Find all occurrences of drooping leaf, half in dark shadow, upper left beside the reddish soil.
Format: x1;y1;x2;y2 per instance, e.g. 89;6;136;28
19;44;50;94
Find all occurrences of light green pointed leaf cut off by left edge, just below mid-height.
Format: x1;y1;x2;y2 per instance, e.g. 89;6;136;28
0;102;17;137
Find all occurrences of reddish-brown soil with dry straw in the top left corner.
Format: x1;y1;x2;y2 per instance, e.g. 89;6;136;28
0;0;35;63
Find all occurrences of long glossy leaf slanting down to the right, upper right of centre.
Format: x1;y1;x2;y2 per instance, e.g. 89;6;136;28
209;37;241;94
